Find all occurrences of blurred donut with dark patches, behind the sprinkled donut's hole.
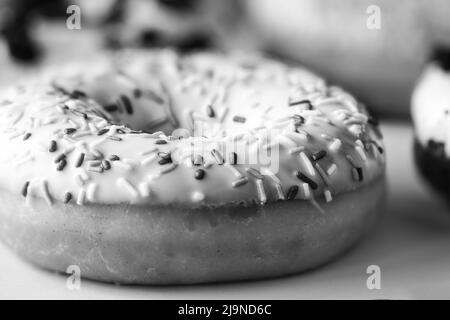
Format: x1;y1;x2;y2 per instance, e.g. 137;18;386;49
99;0;253;51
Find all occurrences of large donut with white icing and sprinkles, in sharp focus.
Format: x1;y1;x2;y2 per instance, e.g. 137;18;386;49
0;50;385;284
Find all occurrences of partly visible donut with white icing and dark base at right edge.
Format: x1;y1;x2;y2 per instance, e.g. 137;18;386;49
412;48;450;199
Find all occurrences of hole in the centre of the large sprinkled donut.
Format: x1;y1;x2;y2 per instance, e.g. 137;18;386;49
64;73;193;138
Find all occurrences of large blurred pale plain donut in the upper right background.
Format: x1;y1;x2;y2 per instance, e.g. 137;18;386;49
243;0;450;116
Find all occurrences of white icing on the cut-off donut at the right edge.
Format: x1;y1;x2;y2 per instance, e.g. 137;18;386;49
412;64;450;155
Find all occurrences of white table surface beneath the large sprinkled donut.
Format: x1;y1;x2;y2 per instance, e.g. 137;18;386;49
0;122;450;299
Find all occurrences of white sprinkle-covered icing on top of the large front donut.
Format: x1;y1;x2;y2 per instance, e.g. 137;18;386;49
0;50;384;207
